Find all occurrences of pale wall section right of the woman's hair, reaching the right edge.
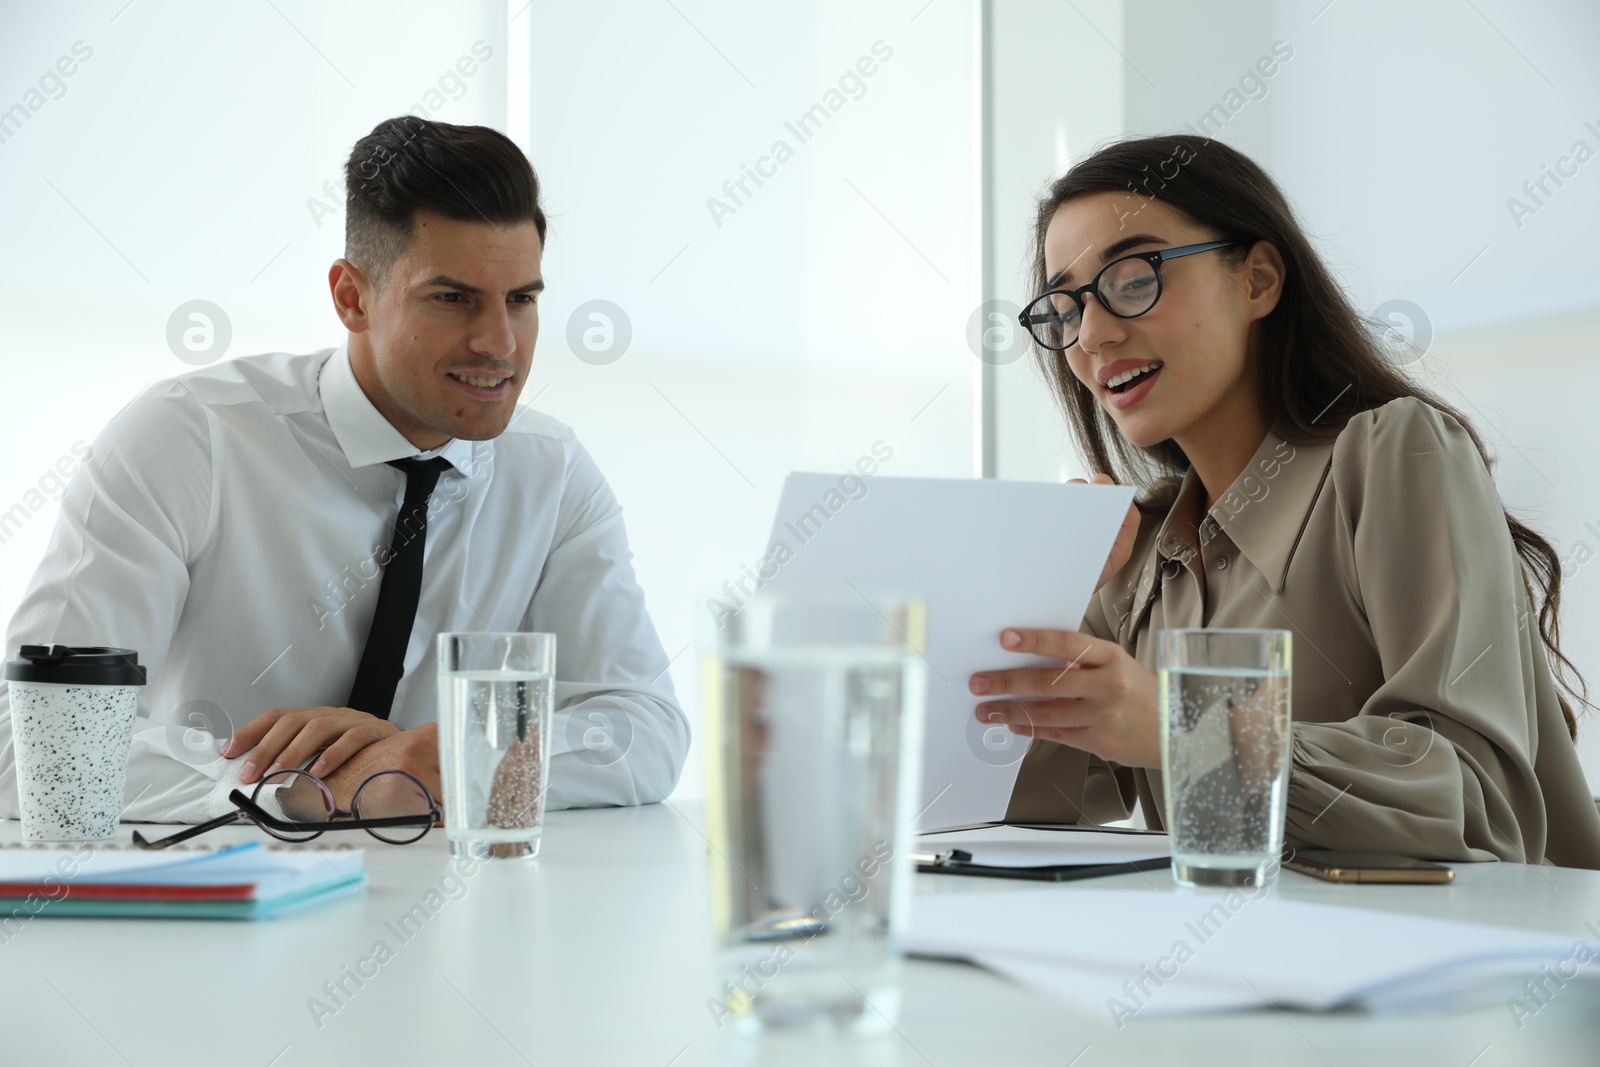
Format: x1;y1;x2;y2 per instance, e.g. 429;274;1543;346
1269;0;1600;792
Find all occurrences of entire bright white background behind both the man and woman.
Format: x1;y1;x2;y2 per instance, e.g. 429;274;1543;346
0;0;1600;795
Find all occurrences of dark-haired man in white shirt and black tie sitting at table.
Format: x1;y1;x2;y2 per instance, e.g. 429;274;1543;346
0;115;688;822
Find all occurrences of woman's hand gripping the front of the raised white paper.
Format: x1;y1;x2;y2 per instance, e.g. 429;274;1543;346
968;630;1162;766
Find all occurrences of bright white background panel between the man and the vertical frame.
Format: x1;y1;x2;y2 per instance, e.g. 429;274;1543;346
531;0;976;793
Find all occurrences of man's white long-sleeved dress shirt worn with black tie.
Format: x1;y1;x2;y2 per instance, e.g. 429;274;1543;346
0;337;688;822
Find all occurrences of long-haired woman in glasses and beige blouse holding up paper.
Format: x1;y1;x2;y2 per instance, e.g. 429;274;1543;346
970;136;1600;869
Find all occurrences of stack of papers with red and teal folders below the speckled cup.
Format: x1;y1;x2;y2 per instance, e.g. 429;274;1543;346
0;841;366;920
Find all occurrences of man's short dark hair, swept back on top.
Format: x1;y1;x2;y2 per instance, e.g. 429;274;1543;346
344;115;546;290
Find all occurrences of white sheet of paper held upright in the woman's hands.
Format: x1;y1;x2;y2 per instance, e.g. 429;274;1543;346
765;474;1133;829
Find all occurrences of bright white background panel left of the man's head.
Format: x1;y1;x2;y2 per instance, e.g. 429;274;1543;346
0;2;506;616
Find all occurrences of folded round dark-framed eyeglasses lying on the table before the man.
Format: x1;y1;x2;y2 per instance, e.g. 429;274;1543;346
133;771;442;849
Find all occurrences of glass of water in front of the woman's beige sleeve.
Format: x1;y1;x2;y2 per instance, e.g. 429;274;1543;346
1155;629;1291;886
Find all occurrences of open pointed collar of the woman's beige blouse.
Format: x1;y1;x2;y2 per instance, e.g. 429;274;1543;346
1155;429;1333;593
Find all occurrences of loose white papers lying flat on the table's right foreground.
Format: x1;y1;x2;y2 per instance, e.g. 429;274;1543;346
906;888;1595;1027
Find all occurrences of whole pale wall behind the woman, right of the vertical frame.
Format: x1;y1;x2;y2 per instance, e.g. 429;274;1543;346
997;0;1600;787
